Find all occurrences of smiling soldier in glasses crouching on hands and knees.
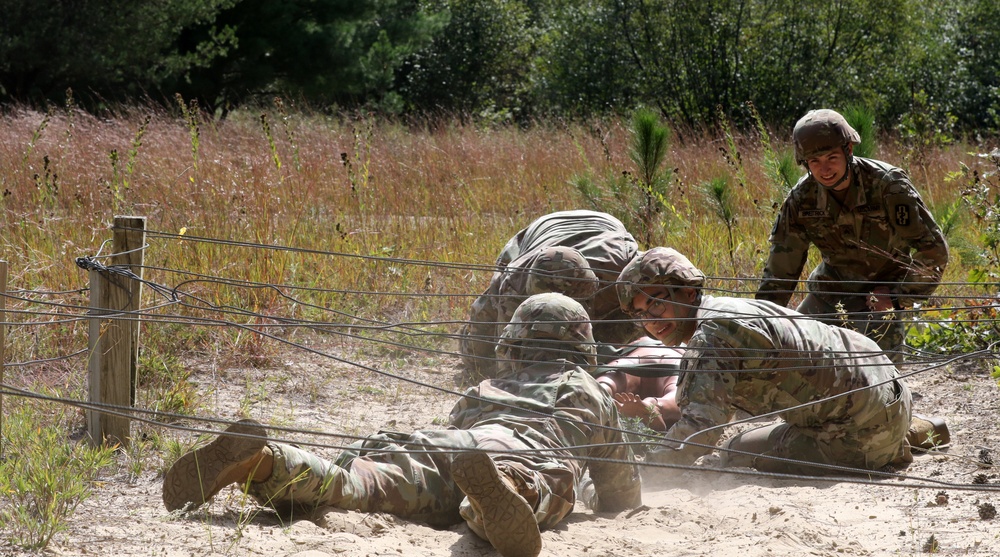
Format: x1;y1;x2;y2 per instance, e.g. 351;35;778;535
618;248;949;475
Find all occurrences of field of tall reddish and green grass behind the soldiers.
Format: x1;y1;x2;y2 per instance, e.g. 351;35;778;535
0;105;998;546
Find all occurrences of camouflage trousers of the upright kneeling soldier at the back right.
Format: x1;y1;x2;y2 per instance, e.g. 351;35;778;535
795;294;906;364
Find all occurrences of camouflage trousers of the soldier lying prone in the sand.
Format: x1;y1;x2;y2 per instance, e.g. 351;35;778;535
250;424;582;532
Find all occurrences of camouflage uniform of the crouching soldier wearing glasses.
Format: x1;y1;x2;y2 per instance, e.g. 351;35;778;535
659;296;911;474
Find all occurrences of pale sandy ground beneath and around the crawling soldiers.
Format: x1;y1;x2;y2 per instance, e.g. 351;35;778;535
0;346;1000;557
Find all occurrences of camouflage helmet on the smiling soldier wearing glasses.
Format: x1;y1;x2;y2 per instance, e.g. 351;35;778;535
615;247;705;314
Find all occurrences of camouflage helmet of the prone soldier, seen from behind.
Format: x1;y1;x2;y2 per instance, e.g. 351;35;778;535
496;292;597;370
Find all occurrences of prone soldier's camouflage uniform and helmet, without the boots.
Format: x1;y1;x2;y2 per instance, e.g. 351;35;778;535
251;294;641;537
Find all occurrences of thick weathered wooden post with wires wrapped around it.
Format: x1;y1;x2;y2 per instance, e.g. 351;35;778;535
87;216;146;446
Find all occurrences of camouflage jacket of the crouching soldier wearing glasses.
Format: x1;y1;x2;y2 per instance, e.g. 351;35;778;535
666;296;897;462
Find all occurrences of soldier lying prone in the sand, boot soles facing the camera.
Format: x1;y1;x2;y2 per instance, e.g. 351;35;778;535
163;293;641;557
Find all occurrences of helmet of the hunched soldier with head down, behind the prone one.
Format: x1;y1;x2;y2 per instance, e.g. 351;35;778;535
524;246;598;300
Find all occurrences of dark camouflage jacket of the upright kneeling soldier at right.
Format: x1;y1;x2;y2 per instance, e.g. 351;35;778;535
757;157;948;307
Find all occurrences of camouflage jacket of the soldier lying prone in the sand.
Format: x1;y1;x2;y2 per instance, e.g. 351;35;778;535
449;361;642;511
